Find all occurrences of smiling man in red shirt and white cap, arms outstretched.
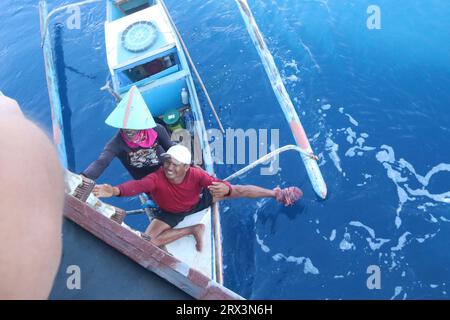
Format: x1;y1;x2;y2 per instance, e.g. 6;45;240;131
94;145;303;251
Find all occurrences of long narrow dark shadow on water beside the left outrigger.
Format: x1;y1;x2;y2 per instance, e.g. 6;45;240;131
55;23;75;171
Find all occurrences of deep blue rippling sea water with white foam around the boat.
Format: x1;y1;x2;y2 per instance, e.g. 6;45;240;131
0;0;450;299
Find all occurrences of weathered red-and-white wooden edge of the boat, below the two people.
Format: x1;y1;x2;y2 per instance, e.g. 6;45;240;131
64;194;243;300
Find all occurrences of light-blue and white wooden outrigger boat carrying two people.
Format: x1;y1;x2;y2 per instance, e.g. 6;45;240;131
39;0;242;299
